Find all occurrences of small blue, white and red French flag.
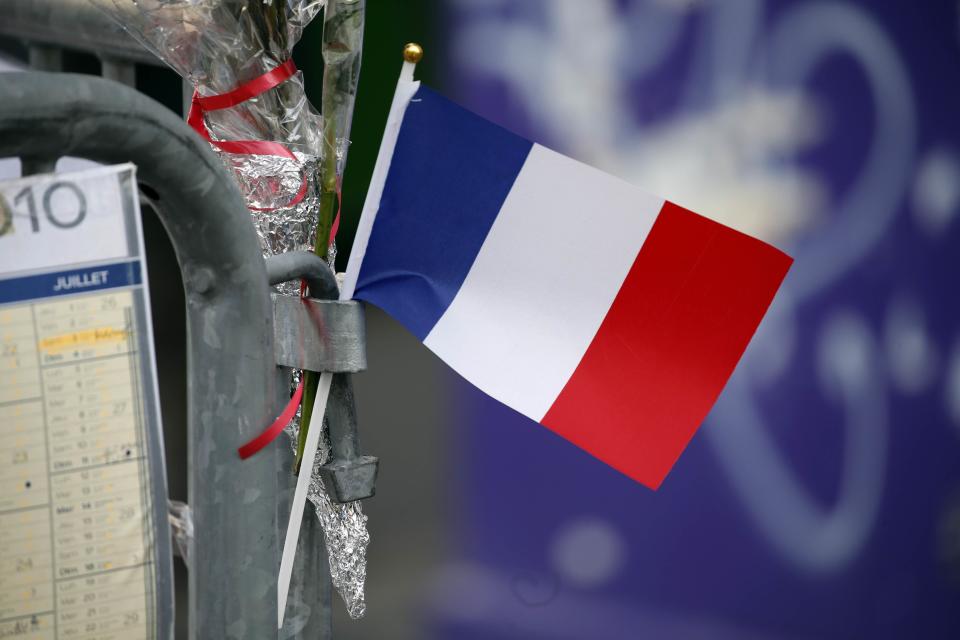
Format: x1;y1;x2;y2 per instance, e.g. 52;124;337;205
342;69;792;489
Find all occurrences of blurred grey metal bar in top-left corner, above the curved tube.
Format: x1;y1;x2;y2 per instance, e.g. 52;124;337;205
0;0;161;65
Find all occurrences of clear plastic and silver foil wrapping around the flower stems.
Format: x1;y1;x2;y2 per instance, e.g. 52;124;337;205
93;0;369;617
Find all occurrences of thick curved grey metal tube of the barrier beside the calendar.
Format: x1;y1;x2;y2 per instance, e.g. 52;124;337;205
0;73;329;640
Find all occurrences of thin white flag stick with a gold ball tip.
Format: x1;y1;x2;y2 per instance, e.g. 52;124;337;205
277;43;423;629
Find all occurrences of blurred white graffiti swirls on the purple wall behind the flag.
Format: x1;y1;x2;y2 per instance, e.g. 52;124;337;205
452;0;940;572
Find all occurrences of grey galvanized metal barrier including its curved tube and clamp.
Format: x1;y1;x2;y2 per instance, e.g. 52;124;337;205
0;27;376;639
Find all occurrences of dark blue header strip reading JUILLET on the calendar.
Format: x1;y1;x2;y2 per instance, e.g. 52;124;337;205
0;260;142;304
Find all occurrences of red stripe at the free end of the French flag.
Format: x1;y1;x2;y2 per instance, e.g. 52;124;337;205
542;202;793;489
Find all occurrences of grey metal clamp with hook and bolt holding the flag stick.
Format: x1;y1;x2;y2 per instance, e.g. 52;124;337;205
266;251;379;502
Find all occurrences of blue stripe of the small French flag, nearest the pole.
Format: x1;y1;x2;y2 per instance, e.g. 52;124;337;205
354;85;532;340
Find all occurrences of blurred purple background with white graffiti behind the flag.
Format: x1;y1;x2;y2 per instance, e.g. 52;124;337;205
0;0;960;640
